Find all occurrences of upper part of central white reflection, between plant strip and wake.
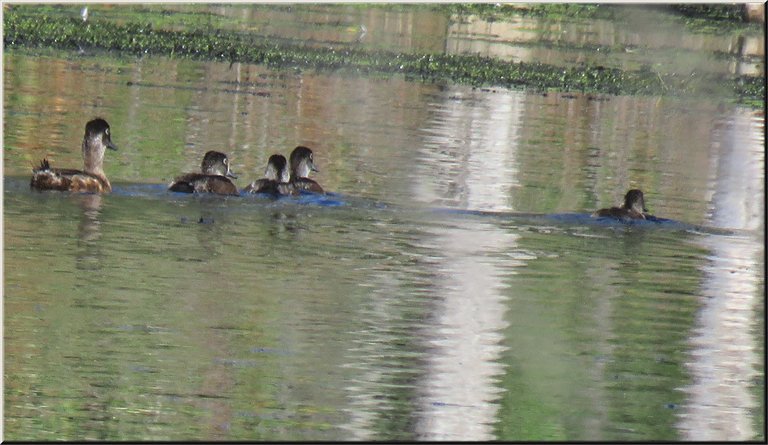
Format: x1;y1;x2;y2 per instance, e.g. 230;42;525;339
413;89;523;211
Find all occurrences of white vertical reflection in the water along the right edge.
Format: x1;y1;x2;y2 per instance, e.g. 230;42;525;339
679;111;765;441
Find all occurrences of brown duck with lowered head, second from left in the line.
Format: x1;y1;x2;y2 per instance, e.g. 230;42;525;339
168;150;240;195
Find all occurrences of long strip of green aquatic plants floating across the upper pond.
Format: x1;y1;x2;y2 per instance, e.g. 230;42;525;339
4;9;765;106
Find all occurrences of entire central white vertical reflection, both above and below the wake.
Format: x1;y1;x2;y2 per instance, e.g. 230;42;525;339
413;89;522;440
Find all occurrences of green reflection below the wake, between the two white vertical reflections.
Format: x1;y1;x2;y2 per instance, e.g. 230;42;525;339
496;224;706;440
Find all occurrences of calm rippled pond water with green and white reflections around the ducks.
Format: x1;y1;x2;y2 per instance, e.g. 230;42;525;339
3;4;765;441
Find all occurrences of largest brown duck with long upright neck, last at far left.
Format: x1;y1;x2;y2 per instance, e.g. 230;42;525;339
29;117;117;193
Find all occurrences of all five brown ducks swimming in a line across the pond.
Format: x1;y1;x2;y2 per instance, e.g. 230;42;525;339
30;118;654;220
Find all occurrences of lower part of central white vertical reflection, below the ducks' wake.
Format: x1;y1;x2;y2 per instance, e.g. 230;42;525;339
416;222;522;441
